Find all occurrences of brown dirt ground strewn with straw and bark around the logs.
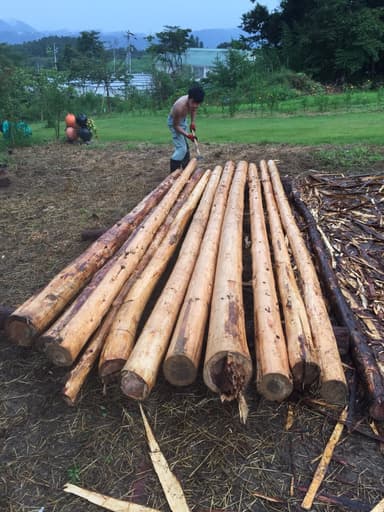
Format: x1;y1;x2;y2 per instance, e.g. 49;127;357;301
0;143;384;512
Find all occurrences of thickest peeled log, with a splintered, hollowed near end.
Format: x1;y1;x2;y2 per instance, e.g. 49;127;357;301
203;161;252;401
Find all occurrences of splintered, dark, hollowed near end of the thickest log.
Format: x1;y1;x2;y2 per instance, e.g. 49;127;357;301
203;351;252;400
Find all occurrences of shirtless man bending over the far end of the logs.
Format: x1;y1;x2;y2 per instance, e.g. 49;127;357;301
168;86;204;172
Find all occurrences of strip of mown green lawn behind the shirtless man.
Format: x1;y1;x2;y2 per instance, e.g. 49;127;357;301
32;112;384;145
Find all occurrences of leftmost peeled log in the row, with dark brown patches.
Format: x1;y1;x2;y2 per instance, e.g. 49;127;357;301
6;170;180;346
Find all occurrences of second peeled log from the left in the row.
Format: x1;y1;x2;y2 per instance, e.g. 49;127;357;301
43;159;197;366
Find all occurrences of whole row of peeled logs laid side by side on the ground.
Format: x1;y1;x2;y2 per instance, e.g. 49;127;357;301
6;159;383;417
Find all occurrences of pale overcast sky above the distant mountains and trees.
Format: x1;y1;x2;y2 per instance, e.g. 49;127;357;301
0;0;280;34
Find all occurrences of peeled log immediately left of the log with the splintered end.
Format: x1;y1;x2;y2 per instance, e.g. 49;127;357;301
163;162;235;386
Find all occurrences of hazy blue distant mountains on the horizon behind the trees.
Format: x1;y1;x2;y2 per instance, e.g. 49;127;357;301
0;20;244;50
